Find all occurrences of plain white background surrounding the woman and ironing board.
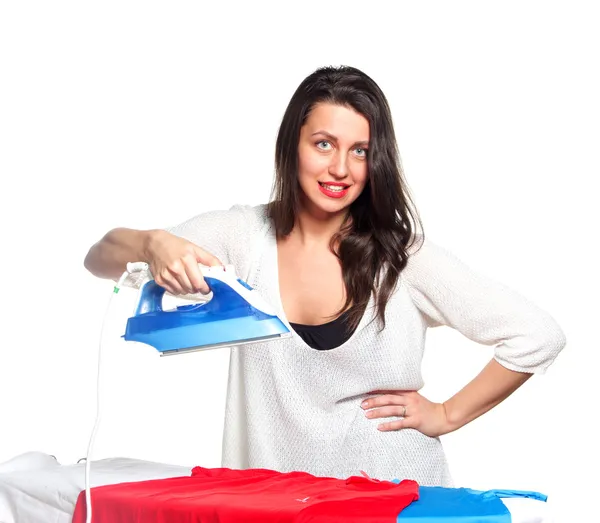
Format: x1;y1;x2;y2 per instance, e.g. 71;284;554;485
0;1;600;523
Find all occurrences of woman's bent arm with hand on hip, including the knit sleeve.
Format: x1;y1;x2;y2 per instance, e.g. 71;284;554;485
363;237;566;437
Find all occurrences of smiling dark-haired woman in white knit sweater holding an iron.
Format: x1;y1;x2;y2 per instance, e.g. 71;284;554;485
85;67;565;486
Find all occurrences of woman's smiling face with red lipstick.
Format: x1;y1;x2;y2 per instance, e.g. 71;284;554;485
298;103;369;216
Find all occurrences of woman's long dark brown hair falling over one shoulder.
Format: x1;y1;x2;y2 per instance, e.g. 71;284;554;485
268;66;423;328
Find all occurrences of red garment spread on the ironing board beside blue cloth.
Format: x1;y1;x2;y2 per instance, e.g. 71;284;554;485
73;467;419;523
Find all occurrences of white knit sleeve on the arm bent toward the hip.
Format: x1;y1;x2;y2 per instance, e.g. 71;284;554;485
402;235;566;374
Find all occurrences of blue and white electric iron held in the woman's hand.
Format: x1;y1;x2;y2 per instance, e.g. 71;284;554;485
123;265;291;356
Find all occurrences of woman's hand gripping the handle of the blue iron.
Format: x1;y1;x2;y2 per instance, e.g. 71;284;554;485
147;231;223;296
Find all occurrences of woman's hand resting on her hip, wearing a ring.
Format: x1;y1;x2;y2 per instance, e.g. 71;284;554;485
361;390;451;438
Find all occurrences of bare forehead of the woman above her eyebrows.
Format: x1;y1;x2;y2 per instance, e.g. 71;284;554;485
303;103;369;142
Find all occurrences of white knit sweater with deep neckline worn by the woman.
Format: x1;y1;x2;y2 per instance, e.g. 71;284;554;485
157;205;566;486
